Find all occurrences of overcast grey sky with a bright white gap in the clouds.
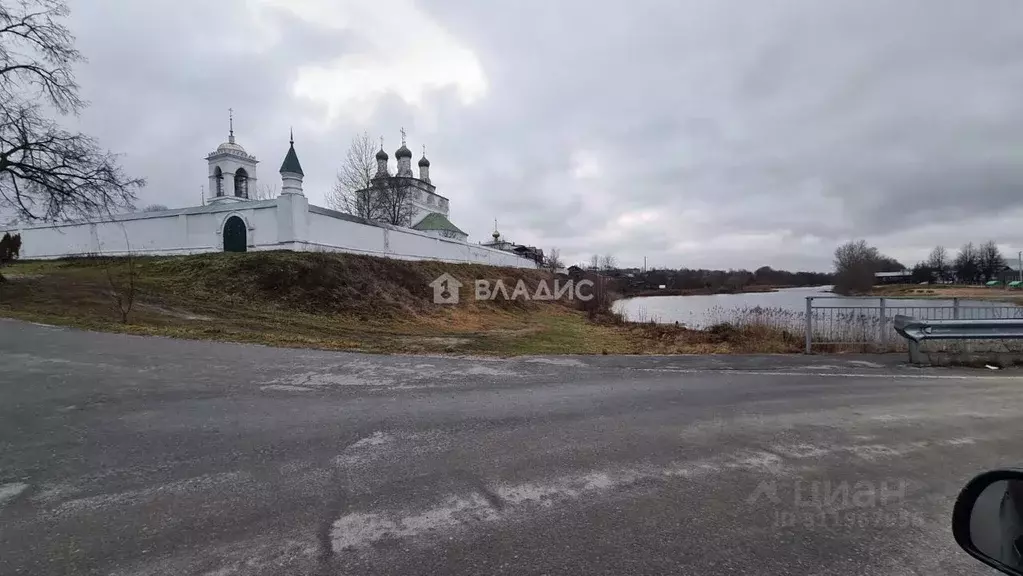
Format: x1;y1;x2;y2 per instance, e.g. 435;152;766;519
58;0;1023;270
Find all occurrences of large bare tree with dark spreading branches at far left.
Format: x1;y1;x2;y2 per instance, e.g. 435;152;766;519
0;0;145;220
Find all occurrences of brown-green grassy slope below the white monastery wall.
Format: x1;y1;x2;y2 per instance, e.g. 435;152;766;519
0;252;799;355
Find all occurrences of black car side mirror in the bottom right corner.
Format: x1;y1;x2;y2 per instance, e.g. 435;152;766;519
952;470;1023;576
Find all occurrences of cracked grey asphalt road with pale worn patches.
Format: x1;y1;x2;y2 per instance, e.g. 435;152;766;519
0;320;1023;576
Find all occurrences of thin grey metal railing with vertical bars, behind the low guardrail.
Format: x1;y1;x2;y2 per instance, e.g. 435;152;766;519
800;296;1023;354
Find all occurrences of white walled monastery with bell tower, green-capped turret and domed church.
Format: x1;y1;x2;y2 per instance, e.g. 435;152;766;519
0;126;536;268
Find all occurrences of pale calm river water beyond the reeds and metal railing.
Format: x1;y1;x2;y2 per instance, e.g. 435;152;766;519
615;286;1013;328
